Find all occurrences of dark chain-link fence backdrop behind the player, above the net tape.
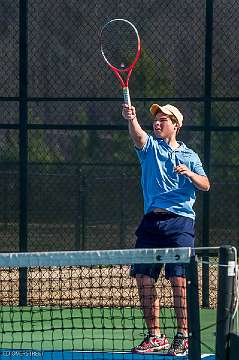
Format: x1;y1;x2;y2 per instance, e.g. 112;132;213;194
0;0;239;251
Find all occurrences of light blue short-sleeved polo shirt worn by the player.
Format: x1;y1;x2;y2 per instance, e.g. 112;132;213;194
136;136;206;219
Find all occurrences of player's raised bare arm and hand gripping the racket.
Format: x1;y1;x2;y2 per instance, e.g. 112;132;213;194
122;104;148;149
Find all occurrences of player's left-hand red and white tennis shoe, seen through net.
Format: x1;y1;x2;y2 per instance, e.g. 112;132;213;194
131;334;170;354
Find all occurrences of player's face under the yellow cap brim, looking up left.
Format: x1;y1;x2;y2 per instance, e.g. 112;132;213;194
153;112;177;139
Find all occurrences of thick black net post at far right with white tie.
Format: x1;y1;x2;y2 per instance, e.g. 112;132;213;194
216;246;236;360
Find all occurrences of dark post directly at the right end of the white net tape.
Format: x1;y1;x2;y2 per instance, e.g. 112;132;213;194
187;256;201;360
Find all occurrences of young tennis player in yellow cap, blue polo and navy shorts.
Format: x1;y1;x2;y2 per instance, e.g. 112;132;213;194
122;104;210;355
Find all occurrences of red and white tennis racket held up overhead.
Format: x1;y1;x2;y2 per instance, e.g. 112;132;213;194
100;19;140;106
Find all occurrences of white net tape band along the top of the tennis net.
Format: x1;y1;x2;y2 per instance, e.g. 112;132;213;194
0;248;192;268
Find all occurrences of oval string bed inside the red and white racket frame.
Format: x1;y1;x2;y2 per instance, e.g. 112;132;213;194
101;21;138;70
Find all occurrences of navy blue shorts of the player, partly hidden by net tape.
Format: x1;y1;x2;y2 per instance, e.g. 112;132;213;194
131;212;195;280
